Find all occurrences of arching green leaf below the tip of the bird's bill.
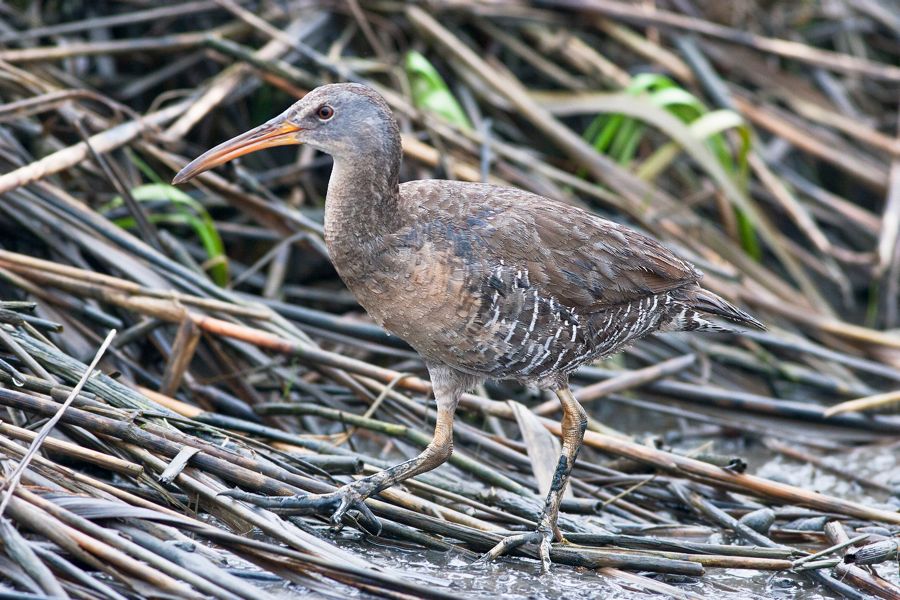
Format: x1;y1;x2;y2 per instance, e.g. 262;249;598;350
101;183;228;286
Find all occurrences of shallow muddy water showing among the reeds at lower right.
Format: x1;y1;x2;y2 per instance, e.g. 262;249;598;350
270;409;900;600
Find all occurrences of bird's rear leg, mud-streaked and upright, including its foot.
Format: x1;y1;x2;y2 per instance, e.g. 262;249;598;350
478;387;587;573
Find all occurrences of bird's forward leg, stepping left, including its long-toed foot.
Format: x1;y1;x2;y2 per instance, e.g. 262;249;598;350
222;382;460;535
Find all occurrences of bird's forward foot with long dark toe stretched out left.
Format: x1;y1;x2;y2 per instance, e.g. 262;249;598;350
219;483;381;535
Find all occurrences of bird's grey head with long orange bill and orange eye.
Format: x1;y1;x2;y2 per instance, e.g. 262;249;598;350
172;83;400;184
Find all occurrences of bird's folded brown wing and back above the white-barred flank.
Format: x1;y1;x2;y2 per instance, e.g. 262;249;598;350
403;180;702;313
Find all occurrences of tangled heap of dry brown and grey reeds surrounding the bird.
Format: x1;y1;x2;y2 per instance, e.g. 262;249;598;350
0;0;900;599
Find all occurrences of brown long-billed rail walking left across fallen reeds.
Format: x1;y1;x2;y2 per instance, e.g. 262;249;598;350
173;83;764;572
